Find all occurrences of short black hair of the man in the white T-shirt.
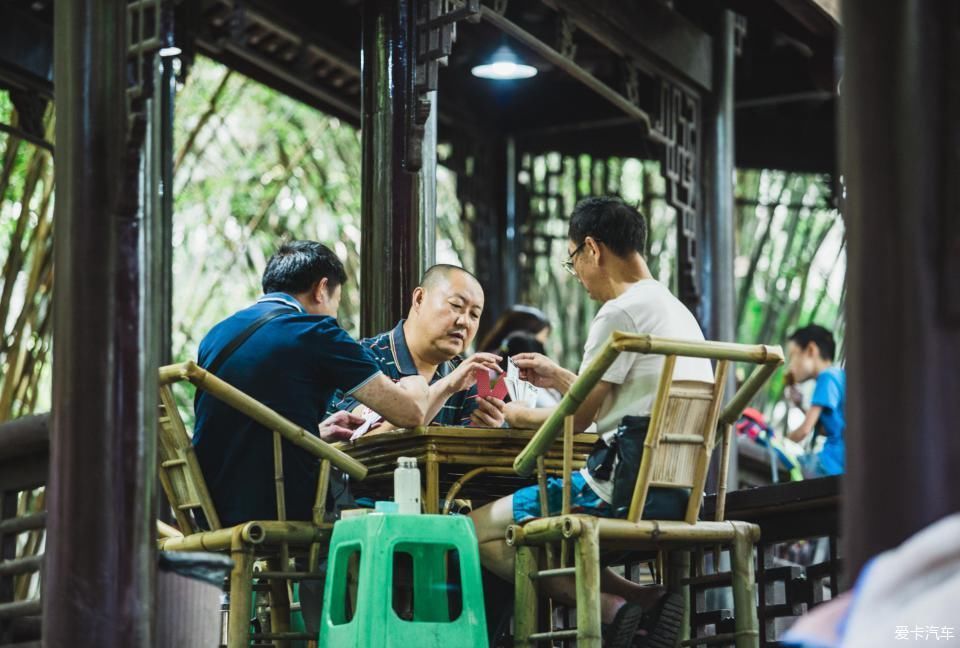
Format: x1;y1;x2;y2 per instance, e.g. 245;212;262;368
567;196;647;257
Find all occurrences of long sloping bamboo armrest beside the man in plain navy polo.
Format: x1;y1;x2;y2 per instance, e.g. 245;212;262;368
160;360;367;480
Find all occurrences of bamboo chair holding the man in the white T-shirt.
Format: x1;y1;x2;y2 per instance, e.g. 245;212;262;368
507;332;783;648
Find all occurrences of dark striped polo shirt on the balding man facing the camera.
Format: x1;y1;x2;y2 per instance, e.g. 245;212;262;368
327;320;477;425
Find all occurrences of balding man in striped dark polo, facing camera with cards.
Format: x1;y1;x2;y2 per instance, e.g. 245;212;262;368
328;264;504;436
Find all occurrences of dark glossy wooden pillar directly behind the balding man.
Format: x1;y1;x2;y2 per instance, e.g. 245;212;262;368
360;0;436;335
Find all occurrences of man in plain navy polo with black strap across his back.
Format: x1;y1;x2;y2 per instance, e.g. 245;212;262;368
193;241;428;526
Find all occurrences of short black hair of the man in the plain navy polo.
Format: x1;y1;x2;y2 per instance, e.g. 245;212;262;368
261;241;347;295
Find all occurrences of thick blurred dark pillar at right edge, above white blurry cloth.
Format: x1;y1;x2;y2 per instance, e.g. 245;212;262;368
840;0;960;578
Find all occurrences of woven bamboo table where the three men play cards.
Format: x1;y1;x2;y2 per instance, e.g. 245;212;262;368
337;426;597;513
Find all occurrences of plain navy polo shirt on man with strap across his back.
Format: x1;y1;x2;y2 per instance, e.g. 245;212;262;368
193;293;380;526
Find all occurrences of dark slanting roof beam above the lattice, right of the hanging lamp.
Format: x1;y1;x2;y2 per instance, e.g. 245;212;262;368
543;0;713;92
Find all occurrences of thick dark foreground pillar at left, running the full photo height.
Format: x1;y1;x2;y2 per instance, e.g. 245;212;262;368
43;0;157;648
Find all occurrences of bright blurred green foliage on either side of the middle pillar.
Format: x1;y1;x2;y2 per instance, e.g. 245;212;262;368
173;58;472;359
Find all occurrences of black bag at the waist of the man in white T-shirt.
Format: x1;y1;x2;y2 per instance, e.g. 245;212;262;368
587;416;690;520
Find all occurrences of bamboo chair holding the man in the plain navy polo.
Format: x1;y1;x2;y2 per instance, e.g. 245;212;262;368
157;361;367;648
